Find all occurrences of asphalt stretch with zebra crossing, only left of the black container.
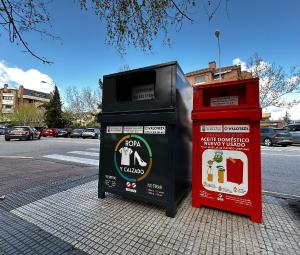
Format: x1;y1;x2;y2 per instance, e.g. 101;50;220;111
0;136;100;195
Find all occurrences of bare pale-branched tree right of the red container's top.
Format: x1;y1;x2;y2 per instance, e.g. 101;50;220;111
248;54;300;108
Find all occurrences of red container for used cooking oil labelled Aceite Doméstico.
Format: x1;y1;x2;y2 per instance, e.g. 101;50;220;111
192;78;262;223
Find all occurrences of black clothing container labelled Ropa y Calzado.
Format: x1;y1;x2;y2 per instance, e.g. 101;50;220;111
98;62;192;217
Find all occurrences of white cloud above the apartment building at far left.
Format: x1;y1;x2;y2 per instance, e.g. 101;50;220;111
0;61;54;93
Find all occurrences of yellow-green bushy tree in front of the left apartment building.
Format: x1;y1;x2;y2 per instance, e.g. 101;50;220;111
9;104;45;127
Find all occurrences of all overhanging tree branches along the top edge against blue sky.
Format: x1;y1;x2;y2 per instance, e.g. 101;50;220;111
0;0;229;63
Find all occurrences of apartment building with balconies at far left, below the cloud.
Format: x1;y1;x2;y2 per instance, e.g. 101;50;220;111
0;84;50;114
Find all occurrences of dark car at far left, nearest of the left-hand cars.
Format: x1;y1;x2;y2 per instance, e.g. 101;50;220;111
5;126;41;141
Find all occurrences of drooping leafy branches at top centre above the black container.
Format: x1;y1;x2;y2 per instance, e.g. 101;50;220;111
79;0;196;52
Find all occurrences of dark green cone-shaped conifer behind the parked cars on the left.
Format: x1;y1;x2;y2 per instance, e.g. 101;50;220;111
44;86;65;128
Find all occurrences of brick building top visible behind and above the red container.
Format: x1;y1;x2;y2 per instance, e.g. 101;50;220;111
185;61;252;86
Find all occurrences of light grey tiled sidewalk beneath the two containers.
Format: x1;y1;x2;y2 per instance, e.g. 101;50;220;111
4;181;300;254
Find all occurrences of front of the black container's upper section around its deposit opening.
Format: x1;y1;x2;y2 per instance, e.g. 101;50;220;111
102;62;177;113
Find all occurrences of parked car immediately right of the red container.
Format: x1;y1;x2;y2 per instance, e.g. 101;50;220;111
260;127;293;146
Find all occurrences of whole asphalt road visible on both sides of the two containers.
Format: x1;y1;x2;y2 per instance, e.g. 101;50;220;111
0;136;300;198
